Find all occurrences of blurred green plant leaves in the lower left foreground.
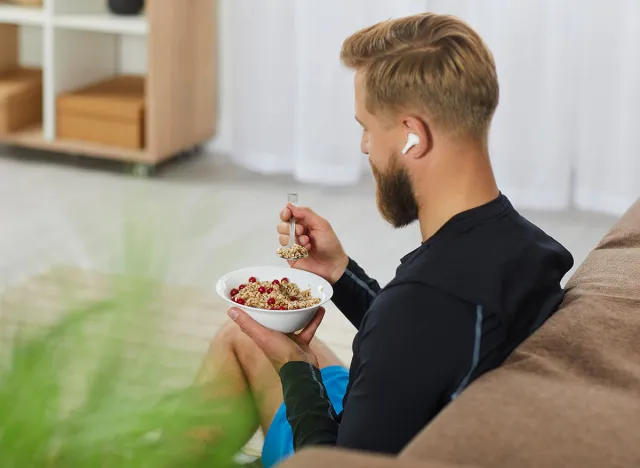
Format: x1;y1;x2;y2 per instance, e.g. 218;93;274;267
0;199;255;468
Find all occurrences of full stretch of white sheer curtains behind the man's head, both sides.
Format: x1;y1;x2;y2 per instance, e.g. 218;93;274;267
222;0;640;213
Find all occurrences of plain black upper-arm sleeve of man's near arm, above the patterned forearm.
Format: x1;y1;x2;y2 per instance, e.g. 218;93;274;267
336;285;479;453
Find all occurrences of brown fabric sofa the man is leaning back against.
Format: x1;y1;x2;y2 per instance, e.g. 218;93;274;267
283;200;640;468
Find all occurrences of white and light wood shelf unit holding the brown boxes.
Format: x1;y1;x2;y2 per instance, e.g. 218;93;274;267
0;0;217;166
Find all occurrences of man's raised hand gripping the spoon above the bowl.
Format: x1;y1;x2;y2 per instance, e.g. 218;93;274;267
278;204;349;284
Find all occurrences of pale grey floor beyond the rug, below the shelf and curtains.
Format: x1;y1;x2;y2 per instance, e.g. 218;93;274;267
0;147;615;454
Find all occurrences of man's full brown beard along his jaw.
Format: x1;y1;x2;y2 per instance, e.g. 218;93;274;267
369;155;418;228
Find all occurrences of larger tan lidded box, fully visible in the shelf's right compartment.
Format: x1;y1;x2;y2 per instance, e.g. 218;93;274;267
56;75;145;149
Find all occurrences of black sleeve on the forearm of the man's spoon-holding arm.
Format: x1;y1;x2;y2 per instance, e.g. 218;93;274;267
331;259;380;330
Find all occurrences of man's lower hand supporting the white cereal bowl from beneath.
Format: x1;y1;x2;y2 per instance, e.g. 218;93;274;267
229;307;324;373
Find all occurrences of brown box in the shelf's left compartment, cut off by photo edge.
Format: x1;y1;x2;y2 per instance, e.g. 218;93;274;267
0;68;42;135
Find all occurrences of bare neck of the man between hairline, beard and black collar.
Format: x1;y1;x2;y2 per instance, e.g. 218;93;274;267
416;147;500;242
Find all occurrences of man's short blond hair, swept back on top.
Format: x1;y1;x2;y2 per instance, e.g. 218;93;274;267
341;13;499;139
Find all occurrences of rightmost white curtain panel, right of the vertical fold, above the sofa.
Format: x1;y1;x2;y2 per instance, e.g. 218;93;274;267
574;0;640;213
